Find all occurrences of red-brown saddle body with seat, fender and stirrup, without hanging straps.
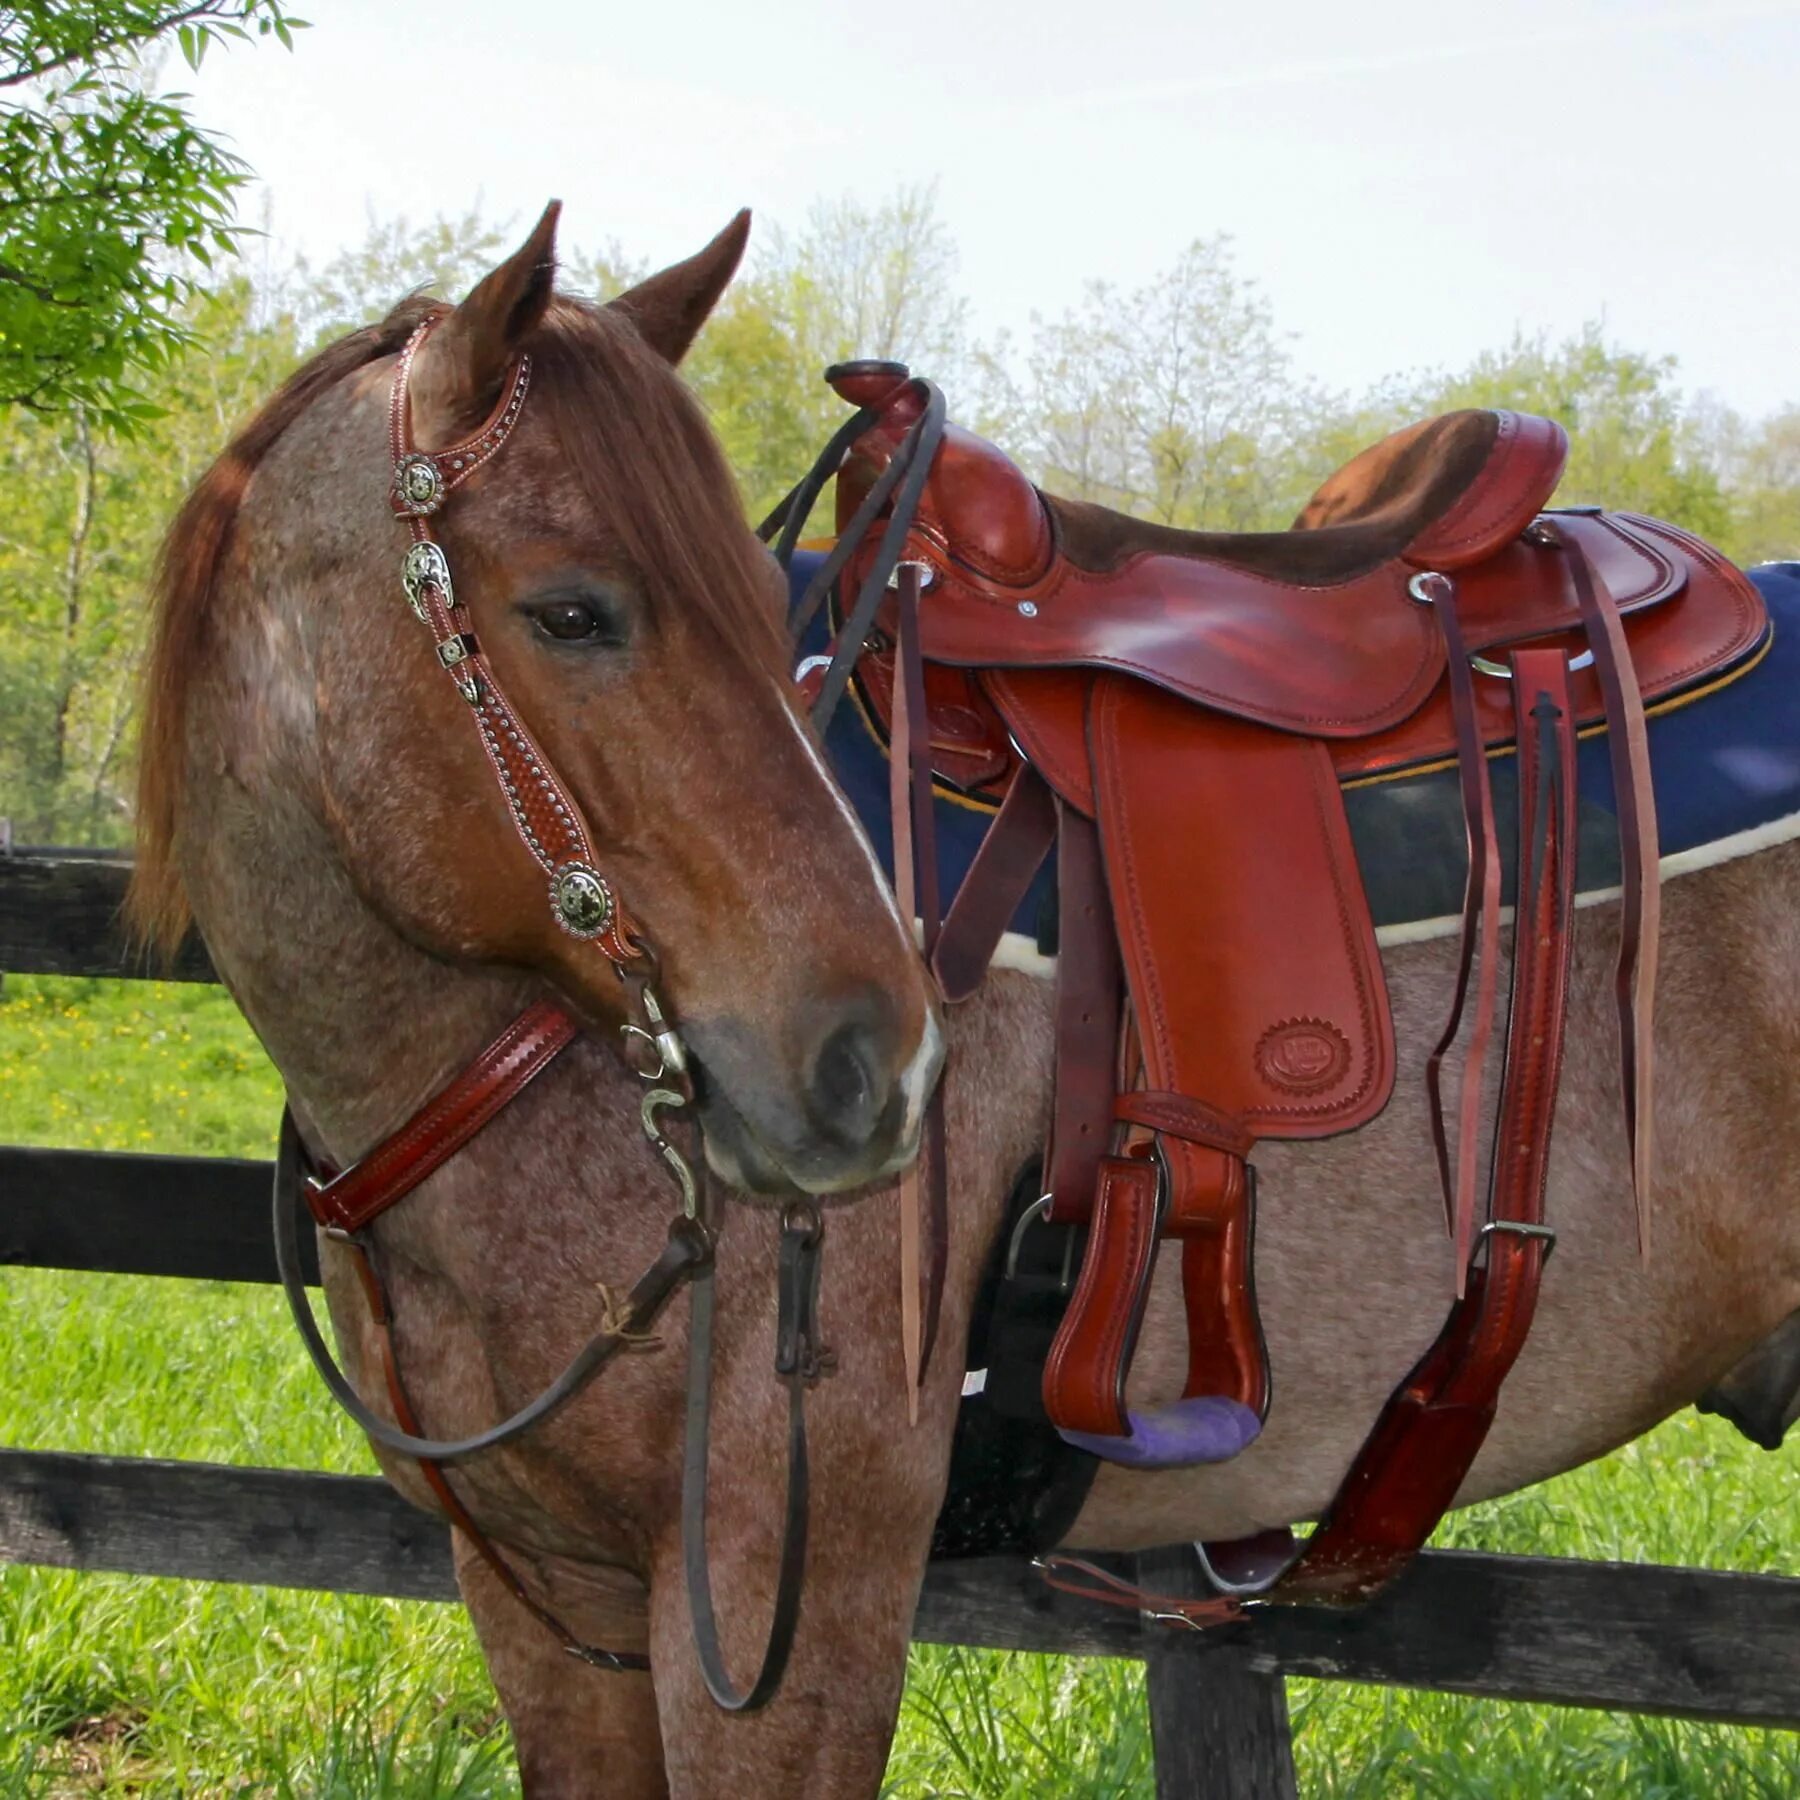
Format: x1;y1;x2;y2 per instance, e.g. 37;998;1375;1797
833;365;1768;1467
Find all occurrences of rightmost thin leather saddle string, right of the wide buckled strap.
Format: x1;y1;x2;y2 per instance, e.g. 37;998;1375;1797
1543;520;1661;1256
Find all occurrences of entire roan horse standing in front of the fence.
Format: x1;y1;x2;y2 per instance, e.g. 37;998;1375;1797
135;209;1800;1796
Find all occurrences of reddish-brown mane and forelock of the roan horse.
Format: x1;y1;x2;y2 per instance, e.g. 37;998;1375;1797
124;295;785;954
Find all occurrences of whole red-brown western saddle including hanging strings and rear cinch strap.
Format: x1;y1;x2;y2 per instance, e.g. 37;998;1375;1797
769;362;1768;1622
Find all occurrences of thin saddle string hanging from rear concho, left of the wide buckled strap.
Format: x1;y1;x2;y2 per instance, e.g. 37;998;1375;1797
1409;571;1501;1298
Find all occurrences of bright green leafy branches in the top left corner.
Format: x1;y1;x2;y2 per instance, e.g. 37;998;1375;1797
0;0;301;430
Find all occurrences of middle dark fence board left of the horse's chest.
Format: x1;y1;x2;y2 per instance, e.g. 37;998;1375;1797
0;1145;319;1282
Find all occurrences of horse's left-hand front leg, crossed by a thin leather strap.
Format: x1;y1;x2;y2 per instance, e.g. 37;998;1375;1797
452;1532;668;1800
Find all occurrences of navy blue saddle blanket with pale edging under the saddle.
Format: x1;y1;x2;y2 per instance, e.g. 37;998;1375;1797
790;551;1800;954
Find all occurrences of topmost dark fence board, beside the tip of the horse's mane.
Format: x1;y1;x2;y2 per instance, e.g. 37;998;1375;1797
0;855;218;981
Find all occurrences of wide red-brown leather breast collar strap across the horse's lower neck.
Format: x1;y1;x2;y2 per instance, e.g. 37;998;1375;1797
306;1001;581;1235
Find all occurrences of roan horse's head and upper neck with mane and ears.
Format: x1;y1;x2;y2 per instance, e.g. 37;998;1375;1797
135;205;941;1193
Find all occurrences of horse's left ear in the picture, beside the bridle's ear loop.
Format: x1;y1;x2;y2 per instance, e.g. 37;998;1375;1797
412;200;562;450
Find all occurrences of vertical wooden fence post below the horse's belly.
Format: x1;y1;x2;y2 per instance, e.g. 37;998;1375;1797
1138;1544;1300;1800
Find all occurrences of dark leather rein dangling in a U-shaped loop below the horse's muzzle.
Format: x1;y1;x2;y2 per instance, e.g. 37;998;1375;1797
680;1202;833;1712
